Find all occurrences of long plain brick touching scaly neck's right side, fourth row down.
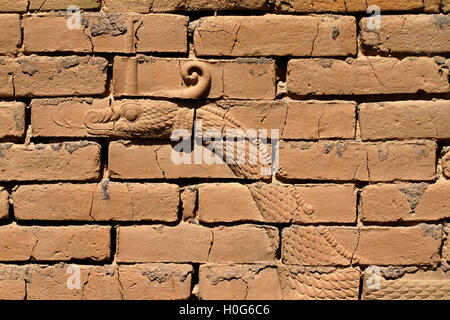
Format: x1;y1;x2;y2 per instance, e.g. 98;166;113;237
278;141;437;181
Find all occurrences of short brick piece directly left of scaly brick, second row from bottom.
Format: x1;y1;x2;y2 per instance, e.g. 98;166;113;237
208;225;280;263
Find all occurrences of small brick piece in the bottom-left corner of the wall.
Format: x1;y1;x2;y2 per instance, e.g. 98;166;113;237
0;264;29;300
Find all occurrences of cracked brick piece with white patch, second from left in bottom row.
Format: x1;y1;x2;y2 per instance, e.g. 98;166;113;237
27;263;122;300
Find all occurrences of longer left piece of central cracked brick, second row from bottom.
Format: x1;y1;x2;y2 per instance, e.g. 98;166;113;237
117;223;213;263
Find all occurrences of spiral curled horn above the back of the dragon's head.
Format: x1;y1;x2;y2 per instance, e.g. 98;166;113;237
181;61;211;99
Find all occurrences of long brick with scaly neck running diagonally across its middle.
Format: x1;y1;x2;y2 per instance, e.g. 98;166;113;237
198;183;356;223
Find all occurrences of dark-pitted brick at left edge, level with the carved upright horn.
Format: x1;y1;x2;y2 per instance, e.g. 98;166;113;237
0;56;108;97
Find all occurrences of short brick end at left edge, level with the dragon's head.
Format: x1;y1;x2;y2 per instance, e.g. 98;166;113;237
0;102;26;139
